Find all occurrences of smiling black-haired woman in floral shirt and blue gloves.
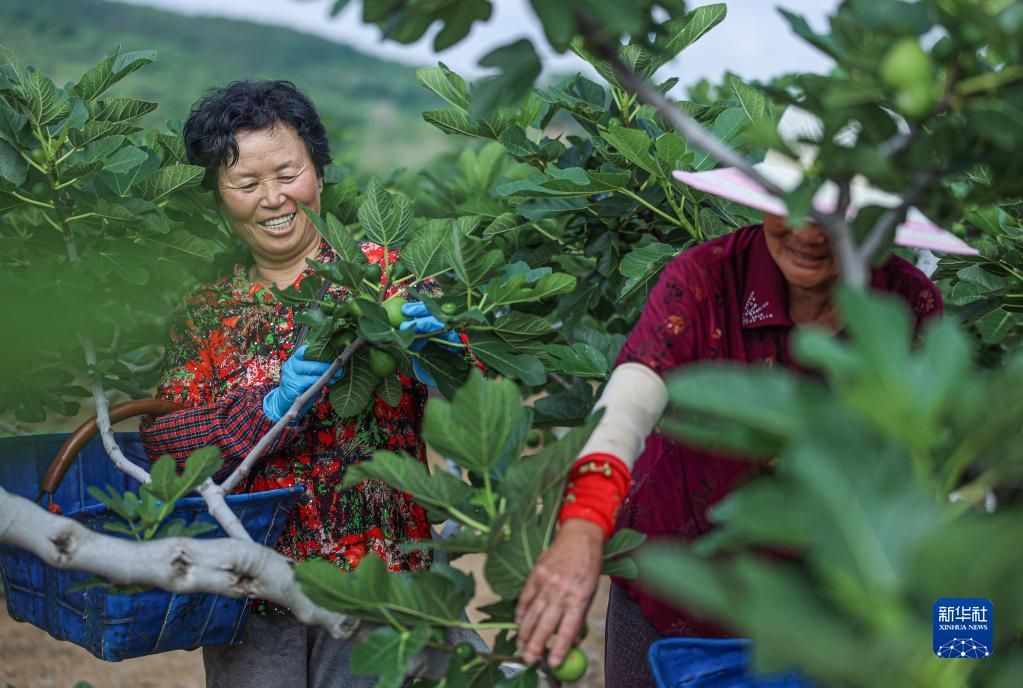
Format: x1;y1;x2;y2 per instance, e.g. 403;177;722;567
140;82;439;688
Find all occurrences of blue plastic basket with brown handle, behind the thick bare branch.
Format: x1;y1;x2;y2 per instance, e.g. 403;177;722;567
0;432;302;661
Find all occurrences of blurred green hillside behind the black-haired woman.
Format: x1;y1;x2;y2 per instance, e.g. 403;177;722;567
0;0;450;174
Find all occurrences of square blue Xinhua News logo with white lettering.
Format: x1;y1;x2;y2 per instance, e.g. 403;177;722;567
934;597;994;659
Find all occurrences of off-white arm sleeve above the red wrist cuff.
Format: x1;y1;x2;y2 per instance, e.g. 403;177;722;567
579;363;668;470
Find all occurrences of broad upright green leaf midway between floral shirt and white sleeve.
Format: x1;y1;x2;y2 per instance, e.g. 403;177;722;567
422;370;531;473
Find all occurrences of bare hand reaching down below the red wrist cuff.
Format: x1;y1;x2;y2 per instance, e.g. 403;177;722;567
516;518;604;667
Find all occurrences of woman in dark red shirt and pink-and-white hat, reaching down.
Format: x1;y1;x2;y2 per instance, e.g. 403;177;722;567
517;159;972;688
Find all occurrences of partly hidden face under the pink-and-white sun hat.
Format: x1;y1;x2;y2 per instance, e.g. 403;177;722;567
764;213;839;290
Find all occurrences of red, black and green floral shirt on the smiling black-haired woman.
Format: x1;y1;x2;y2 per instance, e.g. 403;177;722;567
140;242;431;610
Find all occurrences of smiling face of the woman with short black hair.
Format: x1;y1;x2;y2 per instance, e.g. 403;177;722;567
217;125;323;263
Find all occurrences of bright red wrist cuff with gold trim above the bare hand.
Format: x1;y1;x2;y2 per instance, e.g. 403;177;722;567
558;454;632;540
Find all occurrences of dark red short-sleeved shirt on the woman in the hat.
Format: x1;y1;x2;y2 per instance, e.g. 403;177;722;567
616;226;941;637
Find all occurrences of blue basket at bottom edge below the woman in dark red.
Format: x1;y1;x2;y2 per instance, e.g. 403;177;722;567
649;638;814;688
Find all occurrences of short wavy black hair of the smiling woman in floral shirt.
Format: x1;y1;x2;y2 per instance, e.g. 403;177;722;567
184;81;330;193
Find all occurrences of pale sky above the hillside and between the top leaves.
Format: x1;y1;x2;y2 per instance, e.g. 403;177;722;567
118;0;838;84
